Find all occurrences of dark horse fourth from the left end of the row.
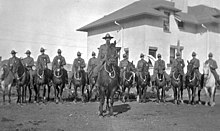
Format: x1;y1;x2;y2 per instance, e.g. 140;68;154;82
53;66;68;103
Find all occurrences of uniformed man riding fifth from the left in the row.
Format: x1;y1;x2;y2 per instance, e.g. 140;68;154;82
72;51;86;75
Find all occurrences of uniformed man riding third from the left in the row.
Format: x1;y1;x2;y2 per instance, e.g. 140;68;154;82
36;47;50;69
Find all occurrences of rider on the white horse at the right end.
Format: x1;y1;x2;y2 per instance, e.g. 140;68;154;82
205;52;220;85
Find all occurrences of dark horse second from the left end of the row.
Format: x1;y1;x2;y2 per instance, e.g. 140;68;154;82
12;58;31;104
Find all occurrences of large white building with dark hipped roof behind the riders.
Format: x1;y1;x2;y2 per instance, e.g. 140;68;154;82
78;0;220;71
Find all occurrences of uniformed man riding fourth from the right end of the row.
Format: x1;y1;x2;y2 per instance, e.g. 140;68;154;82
152;54;170;86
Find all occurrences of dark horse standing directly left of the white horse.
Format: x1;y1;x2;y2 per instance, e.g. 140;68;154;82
185;61;201;105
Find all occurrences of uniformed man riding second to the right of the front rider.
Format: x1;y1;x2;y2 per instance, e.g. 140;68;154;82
136;53;149;77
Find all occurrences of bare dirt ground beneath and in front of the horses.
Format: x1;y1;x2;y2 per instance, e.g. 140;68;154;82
0;86;220;131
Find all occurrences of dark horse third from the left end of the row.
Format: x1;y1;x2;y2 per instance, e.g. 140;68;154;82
34;60;53;103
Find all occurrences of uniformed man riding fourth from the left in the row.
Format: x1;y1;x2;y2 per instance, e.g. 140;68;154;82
52;49;68;84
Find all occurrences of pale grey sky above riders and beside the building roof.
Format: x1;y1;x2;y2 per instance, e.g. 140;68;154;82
0;0;220;63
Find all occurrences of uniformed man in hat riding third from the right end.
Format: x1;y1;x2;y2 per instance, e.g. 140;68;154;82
170;52;185;87
